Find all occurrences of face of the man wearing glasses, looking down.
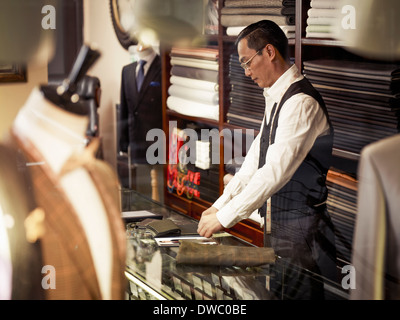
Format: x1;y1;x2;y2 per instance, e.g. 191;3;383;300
238;39;274;88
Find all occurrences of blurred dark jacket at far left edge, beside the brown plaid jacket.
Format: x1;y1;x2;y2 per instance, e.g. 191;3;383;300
0;145;44;300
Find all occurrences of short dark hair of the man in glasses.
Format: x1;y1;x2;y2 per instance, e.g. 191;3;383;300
235;20;289;61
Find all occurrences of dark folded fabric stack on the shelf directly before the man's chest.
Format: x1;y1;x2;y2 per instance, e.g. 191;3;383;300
227;54;265;130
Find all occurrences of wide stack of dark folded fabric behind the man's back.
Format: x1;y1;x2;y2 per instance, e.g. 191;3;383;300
304;60;400;155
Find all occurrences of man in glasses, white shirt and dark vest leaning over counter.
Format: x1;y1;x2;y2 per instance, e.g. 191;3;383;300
198;20;336;297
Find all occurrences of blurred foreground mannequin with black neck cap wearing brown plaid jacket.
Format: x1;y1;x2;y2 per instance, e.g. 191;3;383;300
5;47;125;299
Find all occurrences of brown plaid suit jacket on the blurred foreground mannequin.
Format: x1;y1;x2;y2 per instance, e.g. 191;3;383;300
11;131;126;300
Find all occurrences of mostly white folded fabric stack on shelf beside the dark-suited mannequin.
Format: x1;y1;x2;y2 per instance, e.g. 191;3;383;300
167;47;219;121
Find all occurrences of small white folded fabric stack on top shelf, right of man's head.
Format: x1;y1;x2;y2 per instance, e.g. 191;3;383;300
306;0;340;38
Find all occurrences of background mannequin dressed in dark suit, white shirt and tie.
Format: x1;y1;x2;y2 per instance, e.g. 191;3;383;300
118;42;163;202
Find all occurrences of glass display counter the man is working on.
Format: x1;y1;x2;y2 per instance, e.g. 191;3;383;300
121;190;348;300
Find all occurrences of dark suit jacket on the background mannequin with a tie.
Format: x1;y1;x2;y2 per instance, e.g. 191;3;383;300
119;55;162;164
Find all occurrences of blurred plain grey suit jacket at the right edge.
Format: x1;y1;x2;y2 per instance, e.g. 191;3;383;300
351;134;400;300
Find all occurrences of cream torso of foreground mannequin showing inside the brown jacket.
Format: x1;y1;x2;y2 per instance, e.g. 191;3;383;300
13;89;112;299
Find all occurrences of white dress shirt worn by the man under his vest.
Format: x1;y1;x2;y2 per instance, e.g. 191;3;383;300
213;65;329;228
